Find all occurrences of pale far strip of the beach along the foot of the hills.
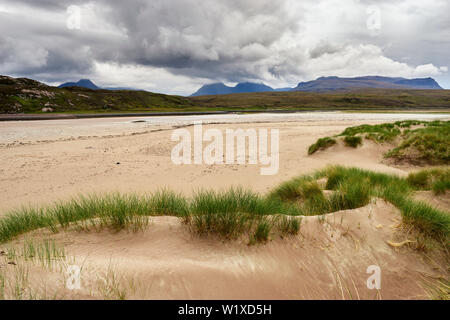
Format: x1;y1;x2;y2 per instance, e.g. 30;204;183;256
0;112;450;143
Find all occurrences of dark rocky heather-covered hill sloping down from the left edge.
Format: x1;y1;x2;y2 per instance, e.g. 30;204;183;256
0;76;194;113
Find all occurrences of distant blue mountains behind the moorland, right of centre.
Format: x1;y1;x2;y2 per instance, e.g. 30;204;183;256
192;76;442;97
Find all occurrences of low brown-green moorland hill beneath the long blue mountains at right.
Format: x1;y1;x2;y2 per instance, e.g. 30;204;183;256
191;89;450;111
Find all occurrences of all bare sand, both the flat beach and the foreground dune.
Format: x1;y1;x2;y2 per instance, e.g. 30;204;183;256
0;113;450;299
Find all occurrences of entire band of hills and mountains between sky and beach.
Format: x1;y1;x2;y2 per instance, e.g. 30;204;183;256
0;75;450;114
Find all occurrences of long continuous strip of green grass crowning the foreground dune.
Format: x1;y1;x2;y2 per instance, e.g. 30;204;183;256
0;166;450;244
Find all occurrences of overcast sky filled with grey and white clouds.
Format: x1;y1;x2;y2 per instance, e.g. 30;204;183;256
0;0;450;95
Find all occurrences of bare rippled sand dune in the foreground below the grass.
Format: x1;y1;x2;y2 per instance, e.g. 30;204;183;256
2;200;447;299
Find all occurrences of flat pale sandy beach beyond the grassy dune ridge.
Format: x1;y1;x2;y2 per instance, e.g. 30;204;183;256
0;112;450;213
